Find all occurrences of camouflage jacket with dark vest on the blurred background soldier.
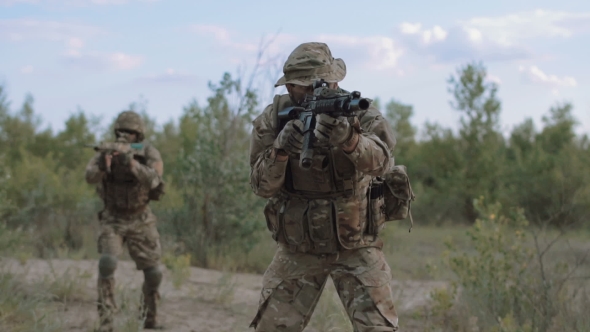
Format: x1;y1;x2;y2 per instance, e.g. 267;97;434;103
86;143;164;215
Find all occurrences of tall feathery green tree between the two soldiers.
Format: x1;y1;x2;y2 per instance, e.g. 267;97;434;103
165;73;263;267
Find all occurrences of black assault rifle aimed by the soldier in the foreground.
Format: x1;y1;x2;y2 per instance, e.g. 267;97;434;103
278;79;371;169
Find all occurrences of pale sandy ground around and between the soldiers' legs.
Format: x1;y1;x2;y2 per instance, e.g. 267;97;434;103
1;259;444;332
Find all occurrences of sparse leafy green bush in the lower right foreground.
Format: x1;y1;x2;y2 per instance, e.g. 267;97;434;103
430;199;590;332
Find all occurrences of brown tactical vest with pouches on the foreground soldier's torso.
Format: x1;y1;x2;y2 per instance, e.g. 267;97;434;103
265;95;382;254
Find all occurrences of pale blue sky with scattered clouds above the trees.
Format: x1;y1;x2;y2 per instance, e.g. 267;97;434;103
0;0;590;137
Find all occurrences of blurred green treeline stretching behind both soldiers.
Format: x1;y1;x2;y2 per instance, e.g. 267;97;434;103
0;62;590;266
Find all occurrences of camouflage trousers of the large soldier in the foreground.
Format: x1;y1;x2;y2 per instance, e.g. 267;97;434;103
250;244;398;332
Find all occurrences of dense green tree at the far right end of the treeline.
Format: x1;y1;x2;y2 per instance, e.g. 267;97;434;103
506;103;590;226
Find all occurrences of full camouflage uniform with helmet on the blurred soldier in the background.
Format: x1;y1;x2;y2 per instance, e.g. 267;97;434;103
86;111;163;331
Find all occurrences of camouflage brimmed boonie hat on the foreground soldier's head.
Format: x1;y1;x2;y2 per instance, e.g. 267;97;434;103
275;42;346;87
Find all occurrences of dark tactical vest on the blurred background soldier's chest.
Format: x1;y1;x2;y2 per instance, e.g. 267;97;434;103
102;145;150;215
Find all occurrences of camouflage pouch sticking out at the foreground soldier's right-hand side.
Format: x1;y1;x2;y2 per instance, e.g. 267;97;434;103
383;165;416;231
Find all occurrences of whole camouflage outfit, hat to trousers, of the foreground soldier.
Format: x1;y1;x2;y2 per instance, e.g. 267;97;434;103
250;43;398;332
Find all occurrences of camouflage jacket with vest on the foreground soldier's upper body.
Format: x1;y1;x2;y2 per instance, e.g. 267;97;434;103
250;95;396;254
